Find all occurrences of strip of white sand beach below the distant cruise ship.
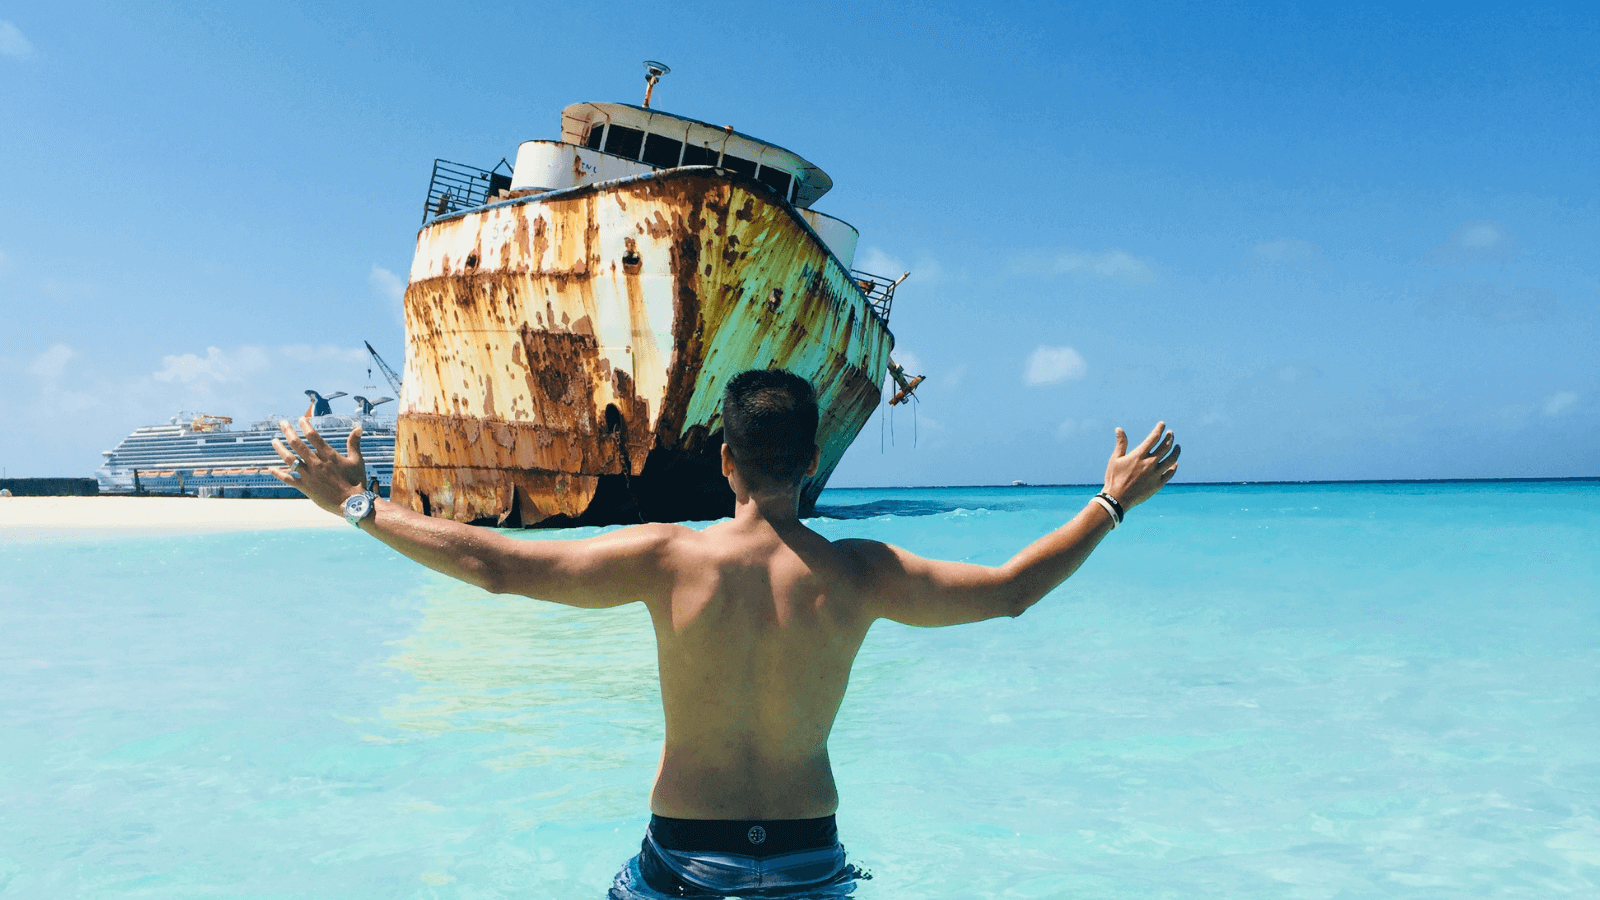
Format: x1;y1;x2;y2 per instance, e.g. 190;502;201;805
0;496;349;540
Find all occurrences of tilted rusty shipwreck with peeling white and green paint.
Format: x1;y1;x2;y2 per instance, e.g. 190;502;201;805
392;64;904;527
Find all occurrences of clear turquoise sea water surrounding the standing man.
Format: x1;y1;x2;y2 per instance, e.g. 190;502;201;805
0;482;1600;900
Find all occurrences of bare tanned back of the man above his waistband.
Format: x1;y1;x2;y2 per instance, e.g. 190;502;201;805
650;519;872;820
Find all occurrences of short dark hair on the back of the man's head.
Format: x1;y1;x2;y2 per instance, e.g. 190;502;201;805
722;368;818;488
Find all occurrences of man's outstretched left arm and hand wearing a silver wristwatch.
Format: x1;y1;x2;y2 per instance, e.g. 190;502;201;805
272;418;677;609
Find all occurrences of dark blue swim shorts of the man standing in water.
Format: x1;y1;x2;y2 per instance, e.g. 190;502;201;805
611;815;858;898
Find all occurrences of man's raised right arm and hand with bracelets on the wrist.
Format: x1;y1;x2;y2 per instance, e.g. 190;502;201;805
842;423;1181;626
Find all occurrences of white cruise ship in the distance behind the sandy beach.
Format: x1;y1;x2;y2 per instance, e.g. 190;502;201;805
94;391;395;496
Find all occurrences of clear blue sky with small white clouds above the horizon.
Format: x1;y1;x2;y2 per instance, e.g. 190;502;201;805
0;0;1600;485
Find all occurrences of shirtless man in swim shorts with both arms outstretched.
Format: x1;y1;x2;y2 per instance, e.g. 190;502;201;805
274;370;1179;897
